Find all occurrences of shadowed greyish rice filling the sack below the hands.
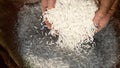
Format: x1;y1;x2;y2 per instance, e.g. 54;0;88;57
16;3;119;68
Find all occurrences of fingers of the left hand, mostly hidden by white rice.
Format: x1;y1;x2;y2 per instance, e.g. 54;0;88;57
41;0;56;29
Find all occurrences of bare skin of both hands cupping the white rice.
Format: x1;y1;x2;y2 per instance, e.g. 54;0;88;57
41;0;118;32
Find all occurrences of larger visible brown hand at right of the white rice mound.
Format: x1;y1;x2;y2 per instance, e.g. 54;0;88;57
93;0;118;32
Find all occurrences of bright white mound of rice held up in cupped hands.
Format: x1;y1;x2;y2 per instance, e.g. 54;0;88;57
43;0;97;49
